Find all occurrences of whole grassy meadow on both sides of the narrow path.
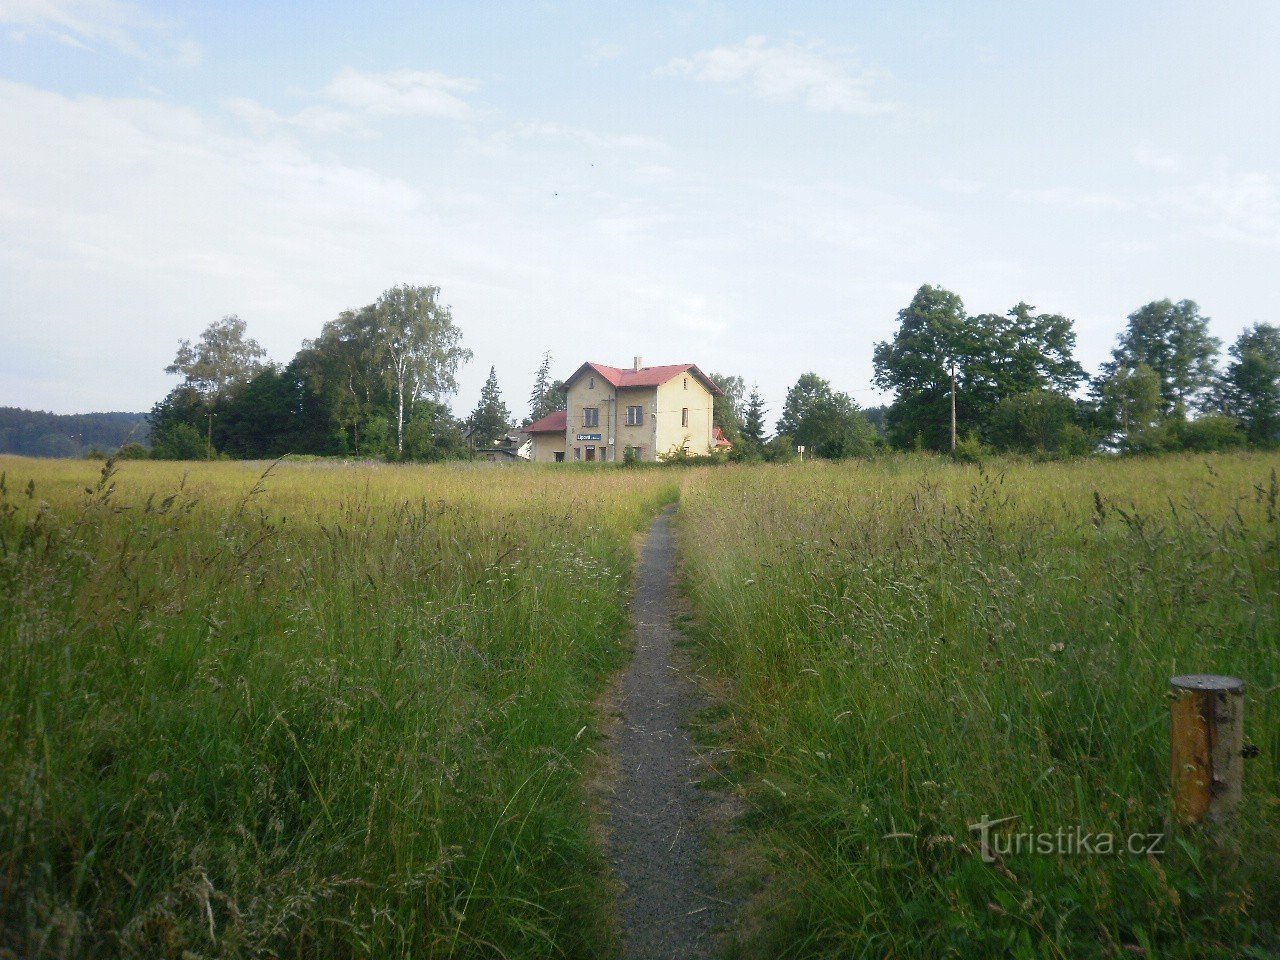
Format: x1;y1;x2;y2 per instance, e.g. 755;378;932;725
0;454;1280;959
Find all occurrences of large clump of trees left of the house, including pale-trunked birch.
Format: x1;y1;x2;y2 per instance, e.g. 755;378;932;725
148;285;471;460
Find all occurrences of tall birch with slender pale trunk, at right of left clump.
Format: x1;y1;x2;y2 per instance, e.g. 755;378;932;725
374;284;471;454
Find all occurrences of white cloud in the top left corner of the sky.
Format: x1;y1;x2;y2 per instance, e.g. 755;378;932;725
0;0;201;65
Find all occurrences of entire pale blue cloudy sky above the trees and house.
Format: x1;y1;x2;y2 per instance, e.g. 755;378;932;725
0;0;1280;417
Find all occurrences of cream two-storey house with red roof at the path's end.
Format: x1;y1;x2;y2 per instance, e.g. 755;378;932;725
525;357;728;463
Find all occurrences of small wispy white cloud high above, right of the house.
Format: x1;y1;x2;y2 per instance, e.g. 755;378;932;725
662;37;892;116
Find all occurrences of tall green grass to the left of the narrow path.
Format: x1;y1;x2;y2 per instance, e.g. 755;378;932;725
0;458;675;957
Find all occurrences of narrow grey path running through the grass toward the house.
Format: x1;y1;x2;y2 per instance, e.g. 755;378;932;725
608;506;722;960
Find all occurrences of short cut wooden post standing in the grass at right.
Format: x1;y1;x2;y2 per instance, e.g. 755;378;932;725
1170;673;1244;826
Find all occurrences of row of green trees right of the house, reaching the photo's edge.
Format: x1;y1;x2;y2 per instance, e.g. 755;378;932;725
714;285;1280;460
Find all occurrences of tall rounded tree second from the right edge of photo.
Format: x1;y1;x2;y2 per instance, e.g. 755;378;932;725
1102;300;1221;416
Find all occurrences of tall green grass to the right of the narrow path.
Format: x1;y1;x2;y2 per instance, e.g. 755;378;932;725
682;456;1280;960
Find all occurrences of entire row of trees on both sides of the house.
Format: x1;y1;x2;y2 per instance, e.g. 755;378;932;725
135;285;1280;461
